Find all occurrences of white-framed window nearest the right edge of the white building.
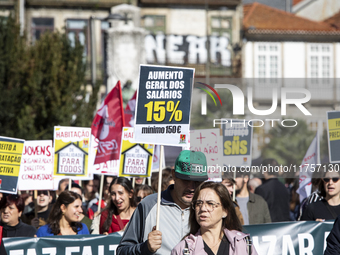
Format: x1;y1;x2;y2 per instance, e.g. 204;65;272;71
307;43;333;79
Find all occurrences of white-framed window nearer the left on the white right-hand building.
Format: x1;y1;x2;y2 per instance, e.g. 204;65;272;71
255;43;281;78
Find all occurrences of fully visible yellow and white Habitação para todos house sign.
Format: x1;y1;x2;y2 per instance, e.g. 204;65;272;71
53;127;91;179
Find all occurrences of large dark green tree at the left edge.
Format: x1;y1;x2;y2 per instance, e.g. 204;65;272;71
0;17;99;140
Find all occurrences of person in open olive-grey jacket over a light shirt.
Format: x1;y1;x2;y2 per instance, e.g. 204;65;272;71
235;172;271;225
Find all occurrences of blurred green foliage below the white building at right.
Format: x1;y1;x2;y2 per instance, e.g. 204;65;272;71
262;120;316;166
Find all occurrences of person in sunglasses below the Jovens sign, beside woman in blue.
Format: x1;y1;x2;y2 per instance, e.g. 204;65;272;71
22;190;52;229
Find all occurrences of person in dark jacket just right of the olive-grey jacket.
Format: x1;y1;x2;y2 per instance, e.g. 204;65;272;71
255;159;290;222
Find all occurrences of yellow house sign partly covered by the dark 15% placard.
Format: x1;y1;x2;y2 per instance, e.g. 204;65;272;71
119;127;154;177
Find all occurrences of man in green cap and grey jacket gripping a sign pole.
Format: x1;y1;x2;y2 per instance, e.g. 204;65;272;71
117;150;208;255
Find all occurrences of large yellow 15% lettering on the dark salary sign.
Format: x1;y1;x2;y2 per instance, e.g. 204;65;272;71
144;101;183;122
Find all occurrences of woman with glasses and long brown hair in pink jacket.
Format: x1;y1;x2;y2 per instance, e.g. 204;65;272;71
171;182;257;255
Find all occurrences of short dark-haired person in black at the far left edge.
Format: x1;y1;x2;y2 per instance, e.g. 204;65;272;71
0;194;37;237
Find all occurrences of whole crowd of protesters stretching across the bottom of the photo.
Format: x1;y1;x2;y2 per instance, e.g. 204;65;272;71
0;150;340;255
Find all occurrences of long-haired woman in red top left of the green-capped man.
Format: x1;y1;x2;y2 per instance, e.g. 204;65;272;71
99;177;136;235
